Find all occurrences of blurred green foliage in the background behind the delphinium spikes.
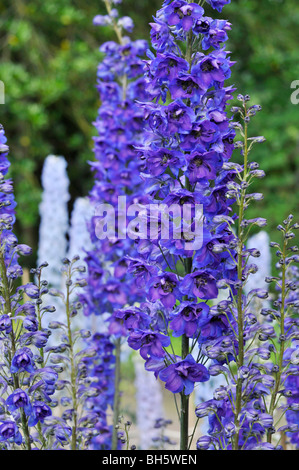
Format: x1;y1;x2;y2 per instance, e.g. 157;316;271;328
0;0;299;264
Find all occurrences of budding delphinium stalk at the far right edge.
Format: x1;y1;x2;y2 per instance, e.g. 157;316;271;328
264;215;299;444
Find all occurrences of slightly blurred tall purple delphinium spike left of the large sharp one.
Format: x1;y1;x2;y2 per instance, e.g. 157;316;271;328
80;0;148;449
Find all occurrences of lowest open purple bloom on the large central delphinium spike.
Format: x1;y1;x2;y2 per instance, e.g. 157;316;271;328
159;354;210;395
